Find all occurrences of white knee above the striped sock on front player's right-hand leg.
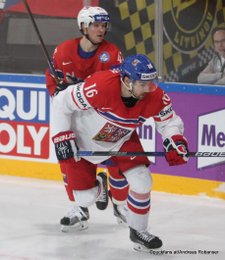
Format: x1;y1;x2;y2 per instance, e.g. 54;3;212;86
124;165;152;194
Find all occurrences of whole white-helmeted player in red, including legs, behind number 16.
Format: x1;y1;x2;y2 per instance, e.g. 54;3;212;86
46;6;127;231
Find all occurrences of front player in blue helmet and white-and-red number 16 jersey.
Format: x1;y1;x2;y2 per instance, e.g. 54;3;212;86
52;54;188;251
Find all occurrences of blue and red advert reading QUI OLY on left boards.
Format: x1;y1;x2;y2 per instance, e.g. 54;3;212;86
0;83;49;159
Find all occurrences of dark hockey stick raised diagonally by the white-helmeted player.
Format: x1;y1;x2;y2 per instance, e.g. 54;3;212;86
20;0;60;85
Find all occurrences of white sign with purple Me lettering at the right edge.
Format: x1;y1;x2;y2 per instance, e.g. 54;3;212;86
197;109;225;168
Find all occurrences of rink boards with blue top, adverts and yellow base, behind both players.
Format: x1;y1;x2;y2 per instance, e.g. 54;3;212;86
0;74;225;199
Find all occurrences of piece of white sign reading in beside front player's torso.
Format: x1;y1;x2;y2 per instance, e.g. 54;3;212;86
137;118;156;163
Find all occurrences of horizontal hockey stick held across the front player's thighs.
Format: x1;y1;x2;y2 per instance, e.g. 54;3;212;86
77;151;225;157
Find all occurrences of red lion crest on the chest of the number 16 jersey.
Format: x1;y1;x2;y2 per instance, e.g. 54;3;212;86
93;123;131;143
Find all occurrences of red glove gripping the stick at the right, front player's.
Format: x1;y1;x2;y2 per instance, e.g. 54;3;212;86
163;135;189;166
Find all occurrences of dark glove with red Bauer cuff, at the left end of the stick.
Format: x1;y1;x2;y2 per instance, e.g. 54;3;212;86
52;131;80;162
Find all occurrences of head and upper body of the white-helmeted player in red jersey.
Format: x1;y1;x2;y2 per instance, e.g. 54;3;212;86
46;6;123;96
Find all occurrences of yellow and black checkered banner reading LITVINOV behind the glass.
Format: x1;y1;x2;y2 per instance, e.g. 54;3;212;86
100;0;225;83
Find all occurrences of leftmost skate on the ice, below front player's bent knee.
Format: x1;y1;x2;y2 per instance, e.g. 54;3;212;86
60;206;89;232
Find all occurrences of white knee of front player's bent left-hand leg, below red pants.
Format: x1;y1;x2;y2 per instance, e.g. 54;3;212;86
73;187;98;207
